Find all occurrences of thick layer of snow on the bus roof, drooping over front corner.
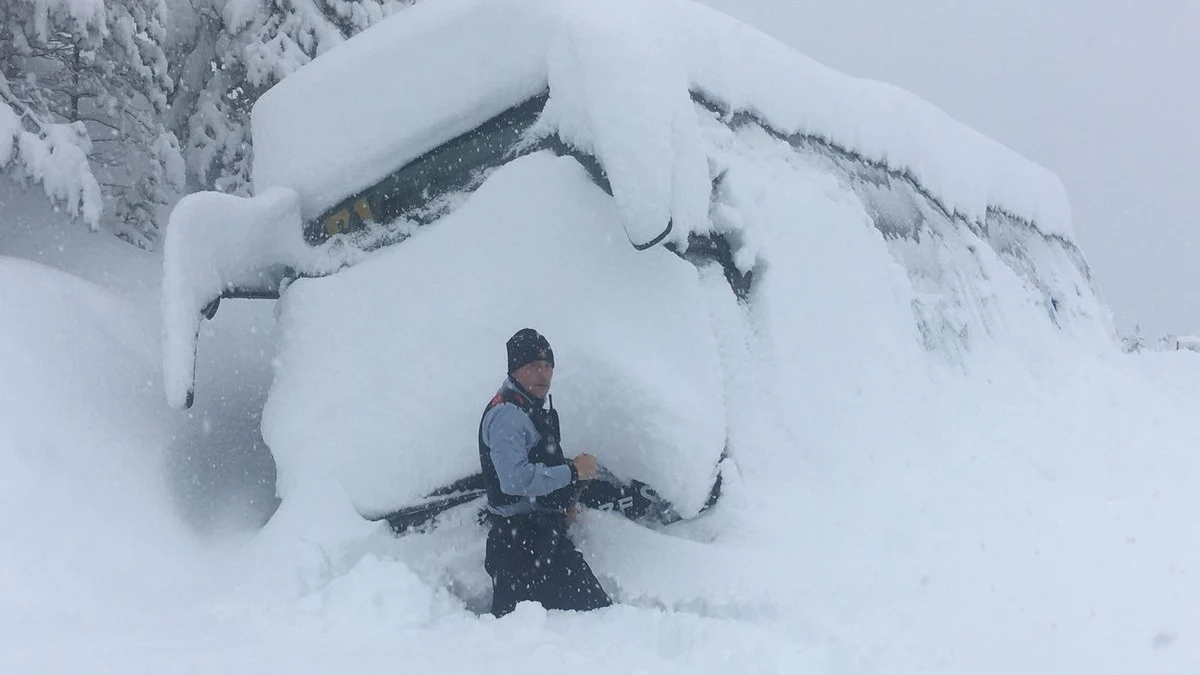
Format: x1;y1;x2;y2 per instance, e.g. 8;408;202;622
253;0;1073;244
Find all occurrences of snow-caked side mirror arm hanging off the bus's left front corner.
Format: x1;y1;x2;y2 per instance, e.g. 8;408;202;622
162;187;316;407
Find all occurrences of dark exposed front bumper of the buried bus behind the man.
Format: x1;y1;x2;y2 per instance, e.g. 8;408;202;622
367;458;721;534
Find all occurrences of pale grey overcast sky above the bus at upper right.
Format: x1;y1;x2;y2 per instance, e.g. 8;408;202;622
704;0;1200;335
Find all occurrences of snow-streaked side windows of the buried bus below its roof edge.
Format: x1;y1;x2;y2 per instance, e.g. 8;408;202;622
702;113;1112;368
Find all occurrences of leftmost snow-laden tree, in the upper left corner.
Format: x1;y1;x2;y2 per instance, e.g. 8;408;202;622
0;0;184;246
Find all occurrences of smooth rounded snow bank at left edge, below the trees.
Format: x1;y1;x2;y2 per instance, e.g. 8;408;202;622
0;257;190;619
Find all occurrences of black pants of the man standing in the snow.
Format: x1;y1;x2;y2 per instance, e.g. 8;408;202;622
484;513;612;616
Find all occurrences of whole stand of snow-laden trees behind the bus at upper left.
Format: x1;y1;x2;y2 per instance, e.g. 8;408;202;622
0;0;415;246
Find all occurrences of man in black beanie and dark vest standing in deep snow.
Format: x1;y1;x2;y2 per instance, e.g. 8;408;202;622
479;328;612;616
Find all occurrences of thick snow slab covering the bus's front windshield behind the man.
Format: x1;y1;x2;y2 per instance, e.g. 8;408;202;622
263;154;726;514
